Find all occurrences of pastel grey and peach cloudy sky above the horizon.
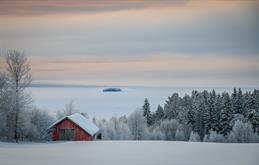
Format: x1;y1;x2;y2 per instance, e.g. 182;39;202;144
0;0;259;87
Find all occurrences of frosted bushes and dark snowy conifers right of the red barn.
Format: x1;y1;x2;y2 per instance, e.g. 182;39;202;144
96;88;259;142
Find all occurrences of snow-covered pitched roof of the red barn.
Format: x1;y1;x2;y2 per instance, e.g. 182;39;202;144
49;113;99;136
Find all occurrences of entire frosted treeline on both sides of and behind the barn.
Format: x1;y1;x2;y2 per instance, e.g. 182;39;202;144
0;51;259;143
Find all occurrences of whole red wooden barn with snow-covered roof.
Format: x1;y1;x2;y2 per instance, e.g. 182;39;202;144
49;113;99;140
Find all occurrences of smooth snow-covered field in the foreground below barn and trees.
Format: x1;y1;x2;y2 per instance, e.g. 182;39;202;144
0;141;259;165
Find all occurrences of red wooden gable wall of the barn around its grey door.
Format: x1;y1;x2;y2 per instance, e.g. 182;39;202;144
51;119;93;140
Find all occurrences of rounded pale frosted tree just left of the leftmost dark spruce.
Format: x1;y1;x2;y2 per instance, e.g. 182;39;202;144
128;109;148;140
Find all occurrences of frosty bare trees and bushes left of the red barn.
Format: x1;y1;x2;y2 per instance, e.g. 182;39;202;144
0;50;53;142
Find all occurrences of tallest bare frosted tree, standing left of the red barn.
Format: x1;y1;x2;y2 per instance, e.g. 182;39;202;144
6;50;32;142
